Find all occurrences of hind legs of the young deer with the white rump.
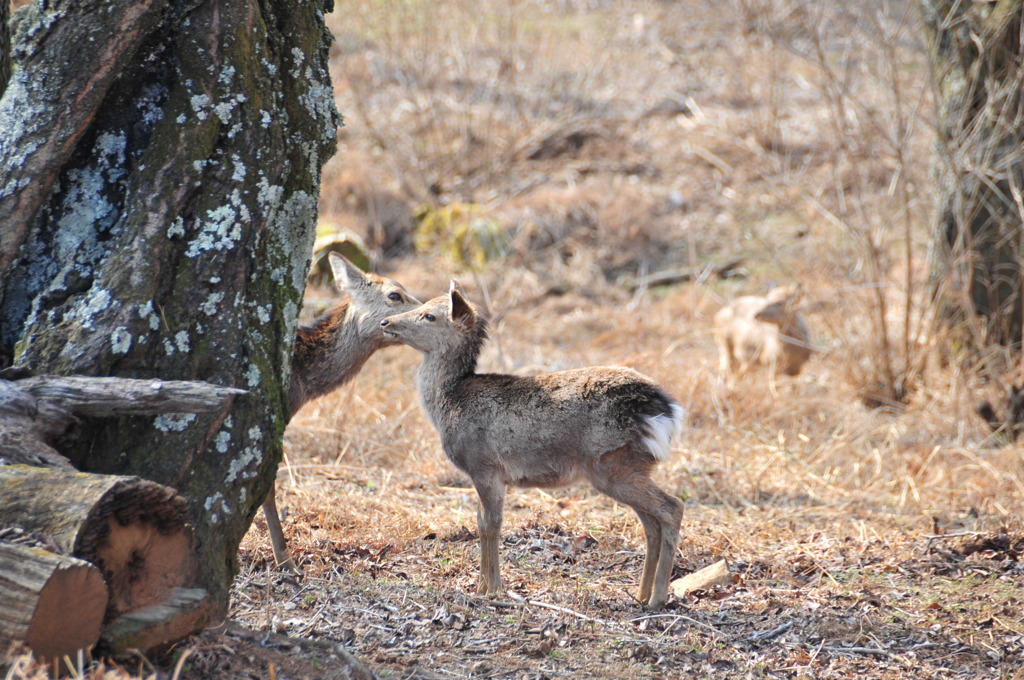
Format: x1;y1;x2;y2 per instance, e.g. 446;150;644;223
591;447;683;609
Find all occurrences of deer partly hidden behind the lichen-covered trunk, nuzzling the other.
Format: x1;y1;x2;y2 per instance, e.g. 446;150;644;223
263;253;420;570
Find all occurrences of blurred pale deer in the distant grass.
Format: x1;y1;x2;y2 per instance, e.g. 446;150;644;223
715;284;811;396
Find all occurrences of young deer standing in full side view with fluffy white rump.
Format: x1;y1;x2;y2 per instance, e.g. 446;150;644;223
381;282;684;609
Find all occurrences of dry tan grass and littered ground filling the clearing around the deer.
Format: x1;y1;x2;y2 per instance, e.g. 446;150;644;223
2;0;1024;678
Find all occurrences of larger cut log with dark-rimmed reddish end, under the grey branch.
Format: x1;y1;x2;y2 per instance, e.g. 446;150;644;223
0;465;196;621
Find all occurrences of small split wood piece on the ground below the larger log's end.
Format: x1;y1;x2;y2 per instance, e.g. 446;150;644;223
100;588;216;654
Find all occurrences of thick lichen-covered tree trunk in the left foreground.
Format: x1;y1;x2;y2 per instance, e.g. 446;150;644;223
0;0;338;610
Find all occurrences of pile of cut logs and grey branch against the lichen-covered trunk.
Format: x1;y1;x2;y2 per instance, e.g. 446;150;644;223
0;376;244;666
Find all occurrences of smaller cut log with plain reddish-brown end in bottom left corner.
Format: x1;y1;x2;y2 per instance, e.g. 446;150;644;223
0;542;108;665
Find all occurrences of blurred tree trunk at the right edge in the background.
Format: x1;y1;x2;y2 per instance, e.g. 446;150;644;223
921;0;1024;349
